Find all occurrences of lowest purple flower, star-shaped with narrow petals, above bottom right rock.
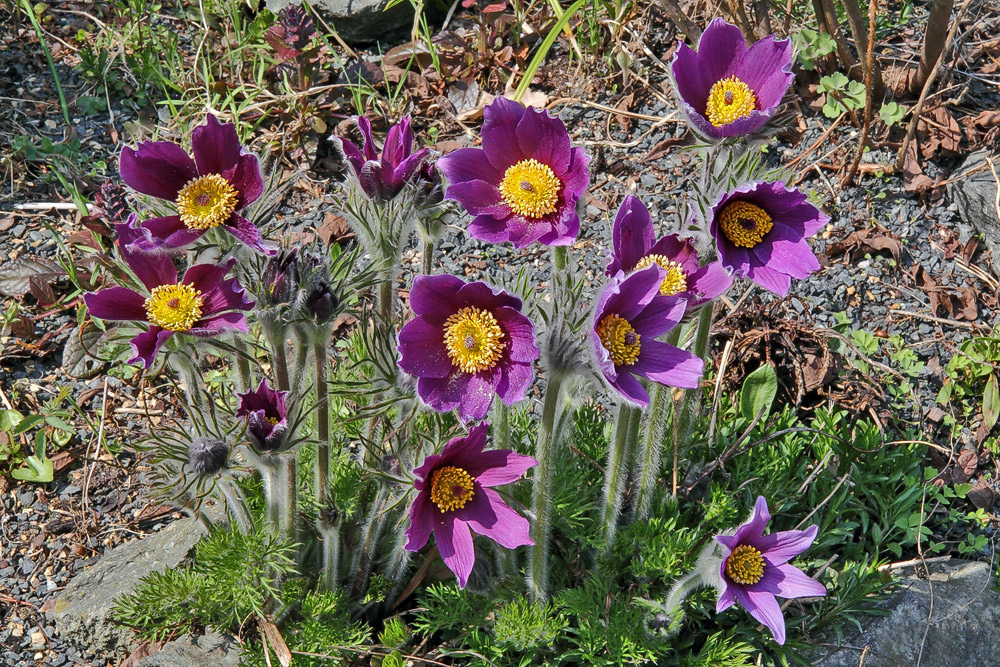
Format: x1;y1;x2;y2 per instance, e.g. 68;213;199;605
715;496;826;644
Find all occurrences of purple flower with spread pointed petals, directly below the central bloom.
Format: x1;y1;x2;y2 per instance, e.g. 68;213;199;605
406;424;538;588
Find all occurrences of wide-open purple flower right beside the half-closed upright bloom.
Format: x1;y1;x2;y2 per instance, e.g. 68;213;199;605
438;97;590;248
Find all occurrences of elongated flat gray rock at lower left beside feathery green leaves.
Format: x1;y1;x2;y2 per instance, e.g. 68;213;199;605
53;518;205;656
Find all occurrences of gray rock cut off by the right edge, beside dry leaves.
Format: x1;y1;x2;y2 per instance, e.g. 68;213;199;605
948;151;1000;276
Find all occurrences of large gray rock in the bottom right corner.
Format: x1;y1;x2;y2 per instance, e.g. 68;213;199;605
811;560;1000;667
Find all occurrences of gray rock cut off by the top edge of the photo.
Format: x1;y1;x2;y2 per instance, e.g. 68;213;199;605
267;0;413;44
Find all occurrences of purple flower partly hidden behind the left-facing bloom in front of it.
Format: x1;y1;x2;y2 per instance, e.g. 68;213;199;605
606;195;733;308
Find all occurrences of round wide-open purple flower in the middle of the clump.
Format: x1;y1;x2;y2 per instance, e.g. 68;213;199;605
399;275;539;421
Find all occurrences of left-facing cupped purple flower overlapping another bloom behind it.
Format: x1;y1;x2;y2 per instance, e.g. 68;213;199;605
590;265;704;407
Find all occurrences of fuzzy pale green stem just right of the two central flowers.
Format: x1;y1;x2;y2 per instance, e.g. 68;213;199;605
528;376;563;600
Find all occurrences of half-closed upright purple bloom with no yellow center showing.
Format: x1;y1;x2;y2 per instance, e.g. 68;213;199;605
336;116;429;201
